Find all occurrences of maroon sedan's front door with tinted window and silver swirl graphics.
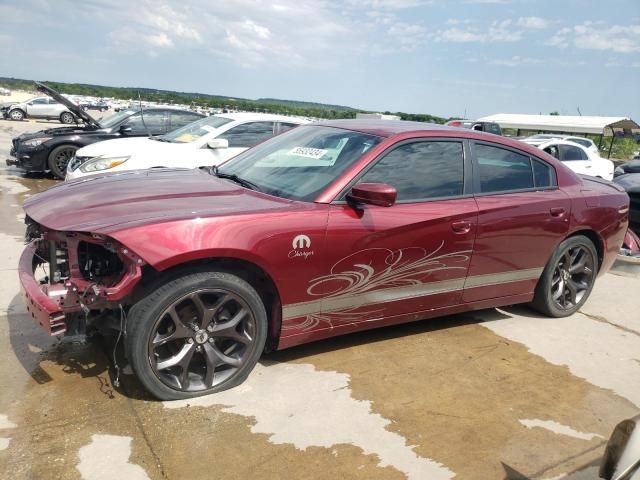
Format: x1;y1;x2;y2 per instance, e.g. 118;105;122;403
307;139;477;333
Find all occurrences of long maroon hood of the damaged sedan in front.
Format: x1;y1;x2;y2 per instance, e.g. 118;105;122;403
24;169;293;234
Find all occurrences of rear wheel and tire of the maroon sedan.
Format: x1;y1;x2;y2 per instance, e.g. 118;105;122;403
531;235;598;318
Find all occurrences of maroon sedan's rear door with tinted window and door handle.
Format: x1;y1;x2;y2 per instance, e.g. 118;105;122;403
463;141;571;302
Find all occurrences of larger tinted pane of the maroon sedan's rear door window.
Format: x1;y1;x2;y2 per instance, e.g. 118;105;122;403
475;143;535;193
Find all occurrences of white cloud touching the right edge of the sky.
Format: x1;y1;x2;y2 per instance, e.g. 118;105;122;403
546;22;640;53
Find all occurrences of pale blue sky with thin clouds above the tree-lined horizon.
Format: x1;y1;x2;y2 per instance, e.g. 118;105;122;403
0;0;640;121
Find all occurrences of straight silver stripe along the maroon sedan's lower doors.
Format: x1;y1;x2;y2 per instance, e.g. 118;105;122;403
282;268;543;321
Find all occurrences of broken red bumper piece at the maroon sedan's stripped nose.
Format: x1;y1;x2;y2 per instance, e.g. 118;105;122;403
18;242;66;335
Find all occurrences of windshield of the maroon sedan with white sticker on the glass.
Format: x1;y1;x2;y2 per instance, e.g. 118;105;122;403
219;126;382;201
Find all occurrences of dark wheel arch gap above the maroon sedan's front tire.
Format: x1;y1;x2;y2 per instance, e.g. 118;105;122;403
133;256;282;351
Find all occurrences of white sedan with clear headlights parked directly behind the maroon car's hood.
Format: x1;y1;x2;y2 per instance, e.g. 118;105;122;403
65;113;309;180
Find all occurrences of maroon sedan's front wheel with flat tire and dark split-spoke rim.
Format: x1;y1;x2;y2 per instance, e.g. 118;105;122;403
125;271;267;400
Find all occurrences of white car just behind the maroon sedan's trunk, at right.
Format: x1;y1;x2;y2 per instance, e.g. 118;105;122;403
523;139;615;180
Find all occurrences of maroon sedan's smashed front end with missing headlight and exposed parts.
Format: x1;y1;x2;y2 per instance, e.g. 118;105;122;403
19;217;145;335
